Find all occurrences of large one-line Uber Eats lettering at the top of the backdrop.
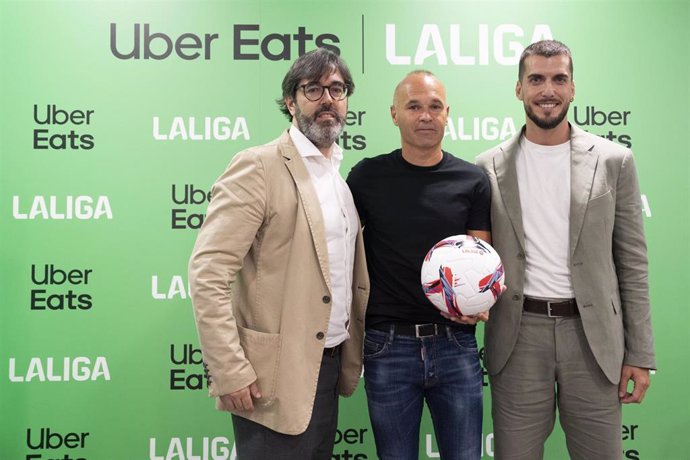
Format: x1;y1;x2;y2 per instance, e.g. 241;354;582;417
110;23;340;61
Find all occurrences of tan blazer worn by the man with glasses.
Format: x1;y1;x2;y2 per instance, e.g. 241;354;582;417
189;131;369;435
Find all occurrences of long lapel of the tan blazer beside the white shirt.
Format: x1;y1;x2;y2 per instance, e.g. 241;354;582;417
278;131;331;290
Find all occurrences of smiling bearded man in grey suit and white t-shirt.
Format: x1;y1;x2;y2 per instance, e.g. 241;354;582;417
477;40;655;460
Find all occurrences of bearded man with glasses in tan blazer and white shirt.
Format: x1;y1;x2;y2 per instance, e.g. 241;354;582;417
189;49;369;460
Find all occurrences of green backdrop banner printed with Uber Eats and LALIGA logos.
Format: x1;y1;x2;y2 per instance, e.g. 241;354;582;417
0;0;690;460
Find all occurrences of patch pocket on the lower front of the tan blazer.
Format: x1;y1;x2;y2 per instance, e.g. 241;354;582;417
237;325;282;406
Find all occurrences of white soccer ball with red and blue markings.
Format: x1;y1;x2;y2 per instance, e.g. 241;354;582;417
422;235;505;316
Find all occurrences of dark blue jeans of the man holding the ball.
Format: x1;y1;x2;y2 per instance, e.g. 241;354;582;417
364;326;482;460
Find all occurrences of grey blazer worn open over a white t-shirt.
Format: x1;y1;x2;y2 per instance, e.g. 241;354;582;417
477;125;655;383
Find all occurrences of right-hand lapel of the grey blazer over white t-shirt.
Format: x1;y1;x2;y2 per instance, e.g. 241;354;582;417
570;125;599;256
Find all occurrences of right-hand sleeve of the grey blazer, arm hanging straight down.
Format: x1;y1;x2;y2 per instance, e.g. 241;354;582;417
613;150;656;369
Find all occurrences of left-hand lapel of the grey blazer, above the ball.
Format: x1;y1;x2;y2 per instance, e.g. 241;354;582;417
494;133;525;252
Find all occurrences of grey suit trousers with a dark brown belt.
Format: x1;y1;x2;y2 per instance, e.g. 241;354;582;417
490;312;623;460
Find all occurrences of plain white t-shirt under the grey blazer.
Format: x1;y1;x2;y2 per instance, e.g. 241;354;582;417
516;136;575;299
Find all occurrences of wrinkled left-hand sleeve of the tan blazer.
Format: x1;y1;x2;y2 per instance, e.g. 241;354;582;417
189;149;266;396
